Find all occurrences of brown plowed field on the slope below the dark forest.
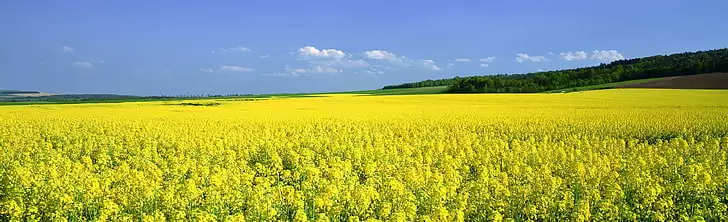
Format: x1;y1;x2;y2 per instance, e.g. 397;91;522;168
617;73;728;89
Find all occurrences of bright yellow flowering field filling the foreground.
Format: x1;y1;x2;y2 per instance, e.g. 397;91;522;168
0;89;728;221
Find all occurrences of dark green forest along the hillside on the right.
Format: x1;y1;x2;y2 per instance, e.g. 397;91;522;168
383;48;728;93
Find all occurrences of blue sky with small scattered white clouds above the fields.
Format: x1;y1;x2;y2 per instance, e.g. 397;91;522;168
0;0;728;95
